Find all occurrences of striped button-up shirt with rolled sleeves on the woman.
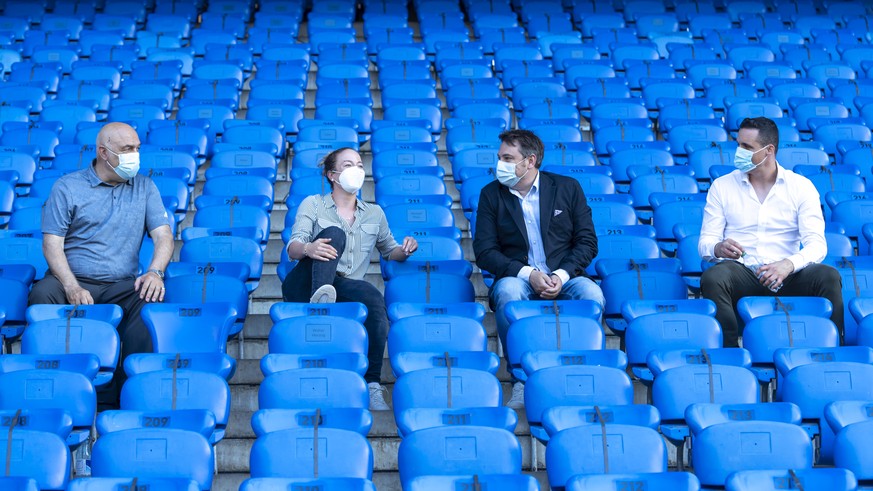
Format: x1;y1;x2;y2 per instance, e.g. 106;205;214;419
285;194;398;280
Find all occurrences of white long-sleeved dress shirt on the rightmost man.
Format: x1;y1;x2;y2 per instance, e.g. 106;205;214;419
697;163;827;271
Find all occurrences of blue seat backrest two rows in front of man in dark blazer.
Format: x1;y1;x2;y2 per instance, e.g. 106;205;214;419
524;365;633;424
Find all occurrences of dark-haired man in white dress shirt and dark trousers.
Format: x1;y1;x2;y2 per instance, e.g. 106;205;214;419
698;117;843;347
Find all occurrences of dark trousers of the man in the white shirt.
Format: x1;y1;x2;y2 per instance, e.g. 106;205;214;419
700;261;843;347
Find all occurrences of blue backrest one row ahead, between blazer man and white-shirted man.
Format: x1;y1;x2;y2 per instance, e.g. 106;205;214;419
625;312;722;365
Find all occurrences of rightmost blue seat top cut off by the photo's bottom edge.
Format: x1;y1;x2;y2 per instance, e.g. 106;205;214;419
725;467;858;491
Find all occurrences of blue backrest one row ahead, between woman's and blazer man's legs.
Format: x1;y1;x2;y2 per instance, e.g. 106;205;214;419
388;315;487;359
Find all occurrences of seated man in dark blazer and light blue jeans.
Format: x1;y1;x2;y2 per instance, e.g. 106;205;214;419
473;130;605;408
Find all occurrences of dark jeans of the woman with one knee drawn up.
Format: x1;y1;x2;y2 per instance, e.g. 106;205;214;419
282;227;388;383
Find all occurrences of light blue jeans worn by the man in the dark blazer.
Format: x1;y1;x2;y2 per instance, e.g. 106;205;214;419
488;276;606;382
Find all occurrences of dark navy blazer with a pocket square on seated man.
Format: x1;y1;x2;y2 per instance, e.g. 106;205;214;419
473;171;597;280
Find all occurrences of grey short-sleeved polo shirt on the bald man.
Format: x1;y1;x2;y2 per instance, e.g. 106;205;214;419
42;165;169;281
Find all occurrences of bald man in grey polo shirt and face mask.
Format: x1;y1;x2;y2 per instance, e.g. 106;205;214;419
29;123;173;406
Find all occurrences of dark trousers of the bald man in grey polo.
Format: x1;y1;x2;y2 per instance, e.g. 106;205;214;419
28;274;152;407
